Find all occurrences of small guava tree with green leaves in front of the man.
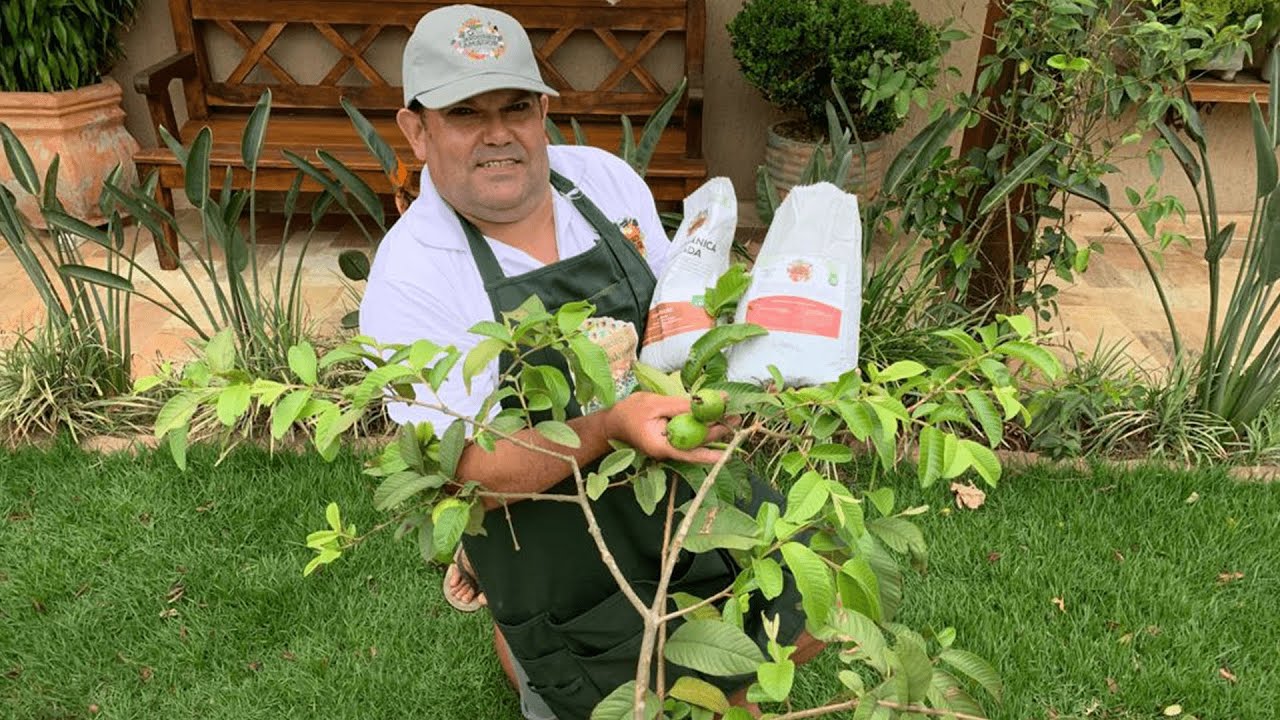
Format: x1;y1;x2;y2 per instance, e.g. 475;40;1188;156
140;270;1059;720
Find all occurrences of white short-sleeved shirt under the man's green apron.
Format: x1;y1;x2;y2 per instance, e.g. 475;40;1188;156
360;145;671;434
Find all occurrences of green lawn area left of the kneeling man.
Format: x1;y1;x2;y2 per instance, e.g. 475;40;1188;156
0;446;517;720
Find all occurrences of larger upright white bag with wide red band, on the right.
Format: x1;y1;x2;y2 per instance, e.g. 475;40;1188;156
728;183;863;387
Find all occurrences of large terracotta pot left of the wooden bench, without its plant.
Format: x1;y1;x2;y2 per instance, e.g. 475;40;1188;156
0;78;138;228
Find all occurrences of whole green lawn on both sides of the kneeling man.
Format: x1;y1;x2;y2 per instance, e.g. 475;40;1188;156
0;446;1280;720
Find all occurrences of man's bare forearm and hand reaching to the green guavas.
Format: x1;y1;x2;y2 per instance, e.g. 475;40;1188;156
457;392;728;509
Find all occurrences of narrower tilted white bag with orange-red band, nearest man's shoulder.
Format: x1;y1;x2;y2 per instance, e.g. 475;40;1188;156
640;178;737;373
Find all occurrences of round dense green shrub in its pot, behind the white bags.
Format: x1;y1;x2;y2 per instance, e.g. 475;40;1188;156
728;0;948;196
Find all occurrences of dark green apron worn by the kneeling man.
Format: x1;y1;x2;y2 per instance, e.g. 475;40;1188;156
458;172;803;720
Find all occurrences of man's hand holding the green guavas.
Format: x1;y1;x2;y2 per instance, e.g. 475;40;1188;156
605;392;730;465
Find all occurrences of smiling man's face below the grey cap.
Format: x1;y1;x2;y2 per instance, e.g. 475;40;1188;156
396;90;550;223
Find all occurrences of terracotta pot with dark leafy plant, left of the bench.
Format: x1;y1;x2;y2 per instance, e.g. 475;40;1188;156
0;0;138;227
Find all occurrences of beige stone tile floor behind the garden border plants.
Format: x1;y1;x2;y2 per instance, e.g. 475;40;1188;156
0;206;1248;373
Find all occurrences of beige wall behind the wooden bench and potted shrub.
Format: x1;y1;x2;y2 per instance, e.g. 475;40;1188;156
111;0;1253;211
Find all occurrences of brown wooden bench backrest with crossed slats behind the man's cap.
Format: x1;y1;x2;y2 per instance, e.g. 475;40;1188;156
169;0;707;129
